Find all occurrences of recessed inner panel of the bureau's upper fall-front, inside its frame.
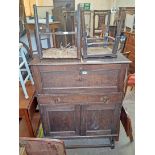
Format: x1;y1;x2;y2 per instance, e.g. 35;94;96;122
41;70;118;88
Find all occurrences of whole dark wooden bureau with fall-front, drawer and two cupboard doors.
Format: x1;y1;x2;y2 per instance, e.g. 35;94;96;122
31;54;130;147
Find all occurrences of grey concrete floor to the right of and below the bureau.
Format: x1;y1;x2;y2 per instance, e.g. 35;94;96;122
67;89;135;155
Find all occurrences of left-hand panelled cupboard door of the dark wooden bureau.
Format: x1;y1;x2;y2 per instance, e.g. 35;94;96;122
40;104;80;137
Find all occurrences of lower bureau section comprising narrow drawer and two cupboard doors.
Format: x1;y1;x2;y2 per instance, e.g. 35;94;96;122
38;93;122;138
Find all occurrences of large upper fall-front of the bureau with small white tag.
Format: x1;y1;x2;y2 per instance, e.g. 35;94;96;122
40;64;121;90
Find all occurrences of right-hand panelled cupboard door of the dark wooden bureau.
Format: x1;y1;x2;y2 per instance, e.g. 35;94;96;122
81;104;121;136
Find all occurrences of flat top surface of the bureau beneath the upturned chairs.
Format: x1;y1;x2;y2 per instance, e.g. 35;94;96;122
30;53;131;65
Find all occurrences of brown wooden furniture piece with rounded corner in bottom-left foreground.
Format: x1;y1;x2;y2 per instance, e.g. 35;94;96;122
20;137;66;155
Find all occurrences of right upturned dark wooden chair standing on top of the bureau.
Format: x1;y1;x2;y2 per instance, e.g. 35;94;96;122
81;11;125;59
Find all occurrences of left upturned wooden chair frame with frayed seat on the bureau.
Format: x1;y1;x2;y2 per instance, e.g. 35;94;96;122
34;5;81;59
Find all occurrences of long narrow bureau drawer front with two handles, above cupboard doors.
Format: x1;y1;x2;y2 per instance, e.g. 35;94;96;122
38;92;123;105
